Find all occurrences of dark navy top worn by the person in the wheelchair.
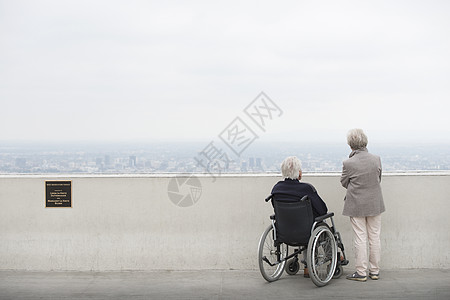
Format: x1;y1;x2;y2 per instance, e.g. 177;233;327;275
272;178;328;218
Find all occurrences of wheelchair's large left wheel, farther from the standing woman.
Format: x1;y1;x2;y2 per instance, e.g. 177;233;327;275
258;225;287;282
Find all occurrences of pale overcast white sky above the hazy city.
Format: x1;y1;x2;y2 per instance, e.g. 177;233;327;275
0;0;450;142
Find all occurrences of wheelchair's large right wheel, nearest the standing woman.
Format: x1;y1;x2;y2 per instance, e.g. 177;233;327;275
306;226;337;287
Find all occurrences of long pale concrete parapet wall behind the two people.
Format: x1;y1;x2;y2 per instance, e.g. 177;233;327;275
0;173;450;270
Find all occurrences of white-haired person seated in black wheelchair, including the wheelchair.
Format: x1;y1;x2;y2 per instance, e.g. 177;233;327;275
258;156;348;287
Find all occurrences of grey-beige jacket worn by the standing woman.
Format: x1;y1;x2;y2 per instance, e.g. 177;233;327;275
341;148;386;217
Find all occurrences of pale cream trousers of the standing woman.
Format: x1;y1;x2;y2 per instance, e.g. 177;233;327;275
350;214;381;276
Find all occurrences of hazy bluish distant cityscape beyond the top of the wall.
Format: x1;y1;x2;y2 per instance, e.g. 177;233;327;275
0;142;450;174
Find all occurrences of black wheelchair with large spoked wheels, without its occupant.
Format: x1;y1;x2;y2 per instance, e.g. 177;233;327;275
258;194;348;287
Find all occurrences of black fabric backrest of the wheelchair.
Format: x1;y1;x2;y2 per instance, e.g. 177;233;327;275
272;194;314;246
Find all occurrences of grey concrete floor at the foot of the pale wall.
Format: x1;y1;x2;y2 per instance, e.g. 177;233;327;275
0;269;450;300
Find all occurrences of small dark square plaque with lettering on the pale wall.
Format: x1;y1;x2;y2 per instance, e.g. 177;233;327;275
45;181;72;207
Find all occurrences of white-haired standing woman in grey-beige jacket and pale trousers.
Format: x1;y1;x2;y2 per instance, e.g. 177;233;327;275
341;129;385;281
